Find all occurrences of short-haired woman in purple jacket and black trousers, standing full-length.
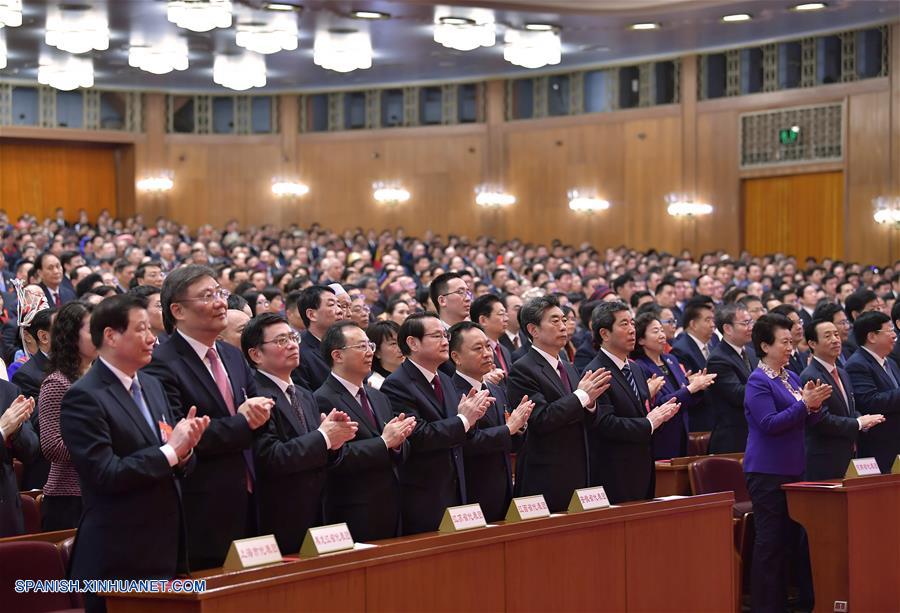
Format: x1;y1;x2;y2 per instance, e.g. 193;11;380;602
744;314;831;611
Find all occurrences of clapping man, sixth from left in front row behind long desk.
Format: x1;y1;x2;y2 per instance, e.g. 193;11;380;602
450;320;534;522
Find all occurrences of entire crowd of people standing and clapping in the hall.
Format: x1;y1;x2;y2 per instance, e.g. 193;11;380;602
0;207;900;610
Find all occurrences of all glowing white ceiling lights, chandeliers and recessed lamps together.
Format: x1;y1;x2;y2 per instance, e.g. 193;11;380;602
0;0;826;91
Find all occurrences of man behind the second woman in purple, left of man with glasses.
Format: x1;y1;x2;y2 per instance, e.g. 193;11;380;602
672;299;716;432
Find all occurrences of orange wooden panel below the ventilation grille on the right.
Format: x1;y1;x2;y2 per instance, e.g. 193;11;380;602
743;172;844;261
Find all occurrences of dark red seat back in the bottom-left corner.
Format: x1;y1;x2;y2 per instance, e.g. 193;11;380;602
0;541;73;613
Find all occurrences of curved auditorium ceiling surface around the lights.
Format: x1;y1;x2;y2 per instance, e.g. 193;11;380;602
0;0;900;92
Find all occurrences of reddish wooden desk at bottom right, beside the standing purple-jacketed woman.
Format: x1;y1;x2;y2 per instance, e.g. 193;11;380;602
783;475;900;612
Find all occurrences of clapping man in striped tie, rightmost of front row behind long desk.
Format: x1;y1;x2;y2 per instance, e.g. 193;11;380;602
586;301;680;503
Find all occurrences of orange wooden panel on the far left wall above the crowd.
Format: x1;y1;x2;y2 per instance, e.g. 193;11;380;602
0;139;117;219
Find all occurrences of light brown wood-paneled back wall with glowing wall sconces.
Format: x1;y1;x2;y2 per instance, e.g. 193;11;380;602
0;25;900;262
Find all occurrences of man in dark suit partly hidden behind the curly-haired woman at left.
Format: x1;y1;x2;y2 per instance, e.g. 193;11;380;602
11;308;56;490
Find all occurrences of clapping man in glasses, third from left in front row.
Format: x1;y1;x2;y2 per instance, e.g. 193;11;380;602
241;313;356;553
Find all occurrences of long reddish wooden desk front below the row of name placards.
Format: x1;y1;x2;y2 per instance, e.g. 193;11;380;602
107;492;735;613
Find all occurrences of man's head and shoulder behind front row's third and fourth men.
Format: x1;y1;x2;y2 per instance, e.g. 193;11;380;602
291;285;343;392
